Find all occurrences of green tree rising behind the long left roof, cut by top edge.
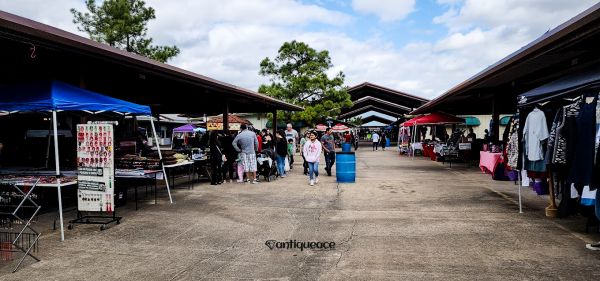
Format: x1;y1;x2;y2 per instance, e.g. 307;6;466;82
71;0;179;62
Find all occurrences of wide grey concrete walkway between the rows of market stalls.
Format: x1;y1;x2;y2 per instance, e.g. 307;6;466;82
0;148;600;281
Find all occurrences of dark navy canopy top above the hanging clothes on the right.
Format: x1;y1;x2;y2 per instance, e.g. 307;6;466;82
518;66;600;105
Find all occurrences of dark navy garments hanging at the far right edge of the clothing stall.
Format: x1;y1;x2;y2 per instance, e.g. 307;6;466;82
569;93;598;186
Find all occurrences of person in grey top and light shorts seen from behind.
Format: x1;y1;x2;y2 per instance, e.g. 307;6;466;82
233;124;258;184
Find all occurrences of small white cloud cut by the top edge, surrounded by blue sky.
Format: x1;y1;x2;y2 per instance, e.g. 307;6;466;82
352;0;415;21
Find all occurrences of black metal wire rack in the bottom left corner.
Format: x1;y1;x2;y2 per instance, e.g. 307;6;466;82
0;179;41;273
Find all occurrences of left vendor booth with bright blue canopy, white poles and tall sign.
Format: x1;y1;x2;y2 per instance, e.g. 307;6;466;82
0;81;173;240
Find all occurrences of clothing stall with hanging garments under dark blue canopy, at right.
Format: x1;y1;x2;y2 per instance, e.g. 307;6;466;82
507;66;600;221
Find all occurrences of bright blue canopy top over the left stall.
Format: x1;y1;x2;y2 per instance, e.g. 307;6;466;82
0;81;150;115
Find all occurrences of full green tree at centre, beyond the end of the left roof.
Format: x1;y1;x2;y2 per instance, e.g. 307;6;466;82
258;41;352;125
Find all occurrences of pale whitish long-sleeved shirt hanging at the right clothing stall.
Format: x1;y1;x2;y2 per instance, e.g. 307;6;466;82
523;107;549;161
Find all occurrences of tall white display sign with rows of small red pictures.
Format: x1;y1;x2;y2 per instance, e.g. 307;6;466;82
77;124;115;212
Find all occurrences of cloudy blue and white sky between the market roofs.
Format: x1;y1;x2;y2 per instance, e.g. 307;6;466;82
0;0;597;99
